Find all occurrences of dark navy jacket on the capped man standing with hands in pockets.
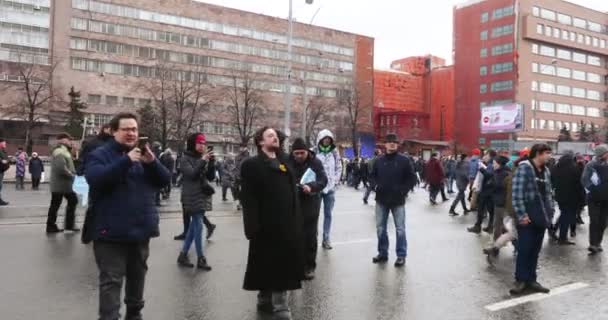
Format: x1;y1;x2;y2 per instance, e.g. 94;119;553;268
371;154;417;207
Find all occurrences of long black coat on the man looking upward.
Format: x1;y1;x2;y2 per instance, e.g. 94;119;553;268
241;152;304;291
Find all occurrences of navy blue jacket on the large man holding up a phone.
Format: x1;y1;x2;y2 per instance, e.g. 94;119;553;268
85;140;171;242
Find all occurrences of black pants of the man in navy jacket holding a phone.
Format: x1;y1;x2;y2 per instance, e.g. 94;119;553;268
93;241;150;320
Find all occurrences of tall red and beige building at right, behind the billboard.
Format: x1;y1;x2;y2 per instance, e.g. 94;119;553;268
454;0;608;149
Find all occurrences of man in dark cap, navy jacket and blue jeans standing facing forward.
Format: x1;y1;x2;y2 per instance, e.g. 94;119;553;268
371;134;416;267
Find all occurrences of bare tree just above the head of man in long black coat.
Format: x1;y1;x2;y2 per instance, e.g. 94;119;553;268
226;71;267;143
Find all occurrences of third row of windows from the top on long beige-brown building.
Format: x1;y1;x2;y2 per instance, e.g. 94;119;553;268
70;38;351;84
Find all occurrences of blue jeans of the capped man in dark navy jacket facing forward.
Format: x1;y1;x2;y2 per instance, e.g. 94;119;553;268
376;202;407;258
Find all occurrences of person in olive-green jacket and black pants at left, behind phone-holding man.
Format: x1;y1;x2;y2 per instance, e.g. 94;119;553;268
46;133;80;233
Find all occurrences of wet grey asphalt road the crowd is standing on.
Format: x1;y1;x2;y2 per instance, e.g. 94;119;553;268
0;186;608;320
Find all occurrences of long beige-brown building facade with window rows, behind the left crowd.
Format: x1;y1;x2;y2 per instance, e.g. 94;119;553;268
0;0;374;152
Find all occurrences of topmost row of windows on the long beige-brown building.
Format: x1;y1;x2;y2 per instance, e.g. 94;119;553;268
72;0;354;57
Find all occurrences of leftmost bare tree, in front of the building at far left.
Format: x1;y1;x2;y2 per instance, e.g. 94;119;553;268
0;56;58;153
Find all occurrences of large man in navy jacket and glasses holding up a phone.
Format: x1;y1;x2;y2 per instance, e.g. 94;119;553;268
85;113;171;320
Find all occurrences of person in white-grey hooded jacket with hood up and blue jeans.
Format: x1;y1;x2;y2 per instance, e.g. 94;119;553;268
315;129;342;250
